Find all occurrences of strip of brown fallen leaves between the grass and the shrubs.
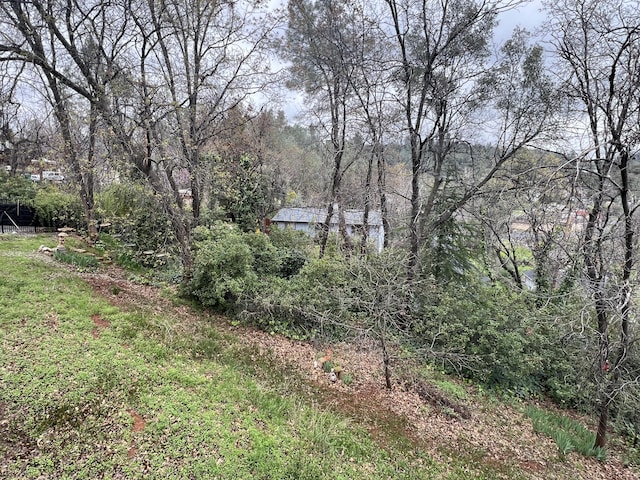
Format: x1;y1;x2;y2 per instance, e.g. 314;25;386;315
83;268;639;480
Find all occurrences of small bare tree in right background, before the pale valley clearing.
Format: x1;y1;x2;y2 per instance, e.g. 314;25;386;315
478;149;583;294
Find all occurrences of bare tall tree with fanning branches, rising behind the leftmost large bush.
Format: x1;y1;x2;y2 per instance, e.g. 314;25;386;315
112;0;277;276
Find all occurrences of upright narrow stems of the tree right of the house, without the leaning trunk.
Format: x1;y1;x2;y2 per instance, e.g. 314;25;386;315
385;0;497;275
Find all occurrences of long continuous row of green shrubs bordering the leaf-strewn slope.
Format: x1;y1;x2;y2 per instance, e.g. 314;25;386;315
182;223;590;406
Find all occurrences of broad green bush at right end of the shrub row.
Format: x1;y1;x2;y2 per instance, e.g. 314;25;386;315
415;282;549;396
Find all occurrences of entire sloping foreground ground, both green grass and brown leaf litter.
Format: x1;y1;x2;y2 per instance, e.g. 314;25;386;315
0;236;640;480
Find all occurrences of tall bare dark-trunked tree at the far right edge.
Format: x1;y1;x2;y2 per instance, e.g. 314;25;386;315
547;0;640;447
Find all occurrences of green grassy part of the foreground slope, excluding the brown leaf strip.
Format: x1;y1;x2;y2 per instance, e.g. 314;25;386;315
0;237;636;480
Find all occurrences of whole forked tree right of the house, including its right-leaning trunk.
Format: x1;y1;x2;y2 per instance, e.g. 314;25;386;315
385;0;552;275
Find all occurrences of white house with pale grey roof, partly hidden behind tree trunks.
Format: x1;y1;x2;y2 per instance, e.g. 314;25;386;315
271;207;384;253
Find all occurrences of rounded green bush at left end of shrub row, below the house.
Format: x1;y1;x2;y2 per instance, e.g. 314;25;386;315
186;222;324;338
